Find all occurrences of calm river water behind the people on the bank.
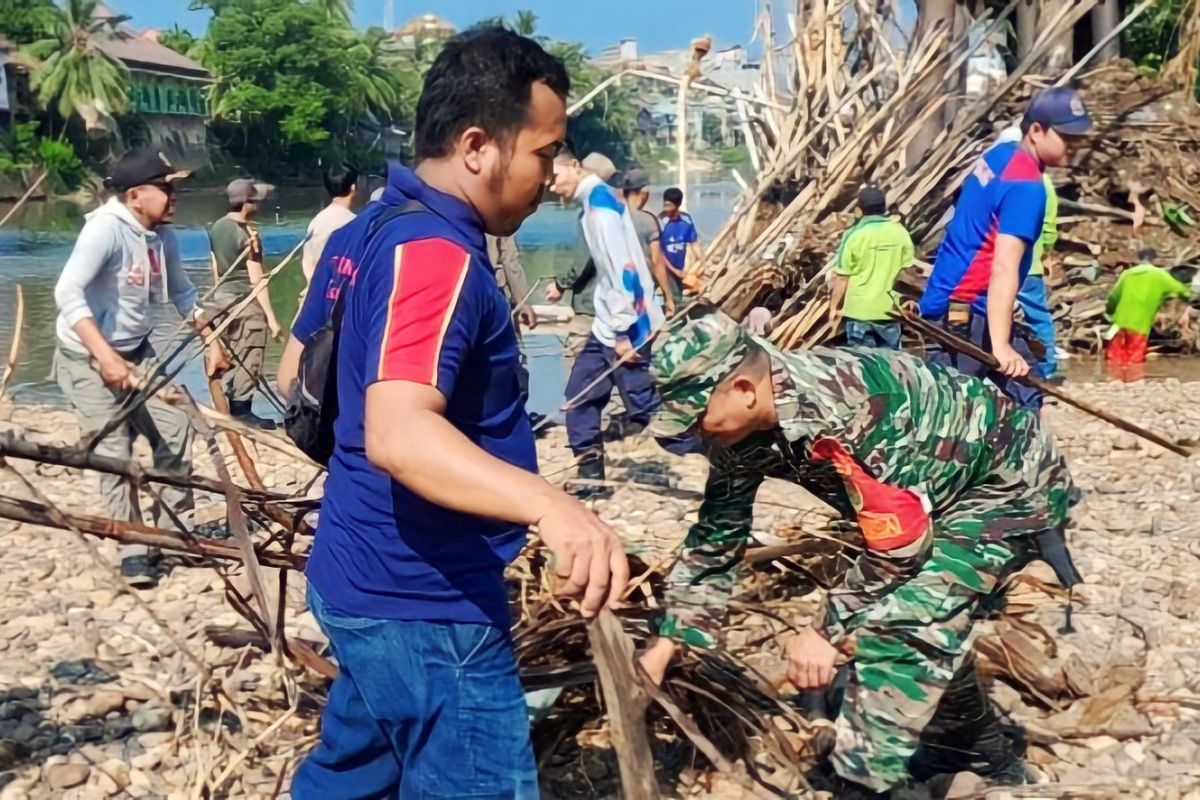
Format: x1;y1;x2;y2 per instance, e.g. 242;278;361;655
0;181;737;413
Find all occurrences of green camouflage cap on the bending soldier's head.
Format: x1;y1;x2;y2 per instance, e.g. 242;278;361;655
649;311;750;437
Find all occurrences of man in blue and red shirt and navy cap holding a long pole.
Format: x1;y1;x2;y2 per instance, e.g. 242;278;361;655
920;86;1092;409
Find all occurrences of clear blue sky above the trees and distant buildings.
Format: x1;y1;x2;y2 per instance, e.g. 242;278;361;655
117;0;763;53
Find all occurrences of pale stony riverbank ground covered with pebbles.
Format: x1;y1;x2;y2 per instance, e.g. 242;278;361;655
0;379;1200;800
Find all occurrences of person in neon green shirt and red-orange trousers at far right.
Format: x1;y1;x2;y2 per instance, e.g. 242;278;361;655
1104;249;1192;365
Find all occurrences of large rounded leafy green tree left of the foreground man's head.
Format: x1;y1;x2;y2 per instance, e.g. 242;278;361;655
198;0;403;174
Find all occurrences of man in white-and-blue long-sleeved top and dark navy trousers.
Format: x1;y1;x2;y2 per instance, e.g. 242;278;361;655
552;151;665;494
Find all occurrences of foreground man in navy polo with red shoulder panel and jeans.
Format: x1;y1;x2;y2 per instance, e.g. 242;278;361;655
292;28;629;800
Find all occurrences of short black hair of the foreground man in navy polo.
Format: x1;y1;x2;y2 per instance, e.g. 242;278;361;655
414;25;571;162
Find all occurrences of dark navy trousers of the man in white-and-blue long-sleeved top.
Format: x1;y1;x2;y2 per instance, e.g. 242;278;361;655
566;333;658;456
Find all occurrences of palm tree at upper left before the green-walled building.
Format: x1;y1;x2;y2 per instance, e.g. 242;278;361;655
29;0;130;126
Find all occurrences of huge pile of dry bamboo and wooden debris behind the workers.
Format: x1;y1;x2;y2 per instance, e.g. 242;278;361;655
703;0;1200;350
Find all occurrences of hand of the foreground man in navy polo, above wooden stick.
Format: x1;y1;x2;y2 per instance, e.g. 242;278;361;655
536;492;629;618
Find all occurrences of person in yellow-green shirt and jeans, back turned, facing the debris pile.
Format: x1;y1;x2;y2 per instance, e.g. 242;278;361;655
829;186;913;350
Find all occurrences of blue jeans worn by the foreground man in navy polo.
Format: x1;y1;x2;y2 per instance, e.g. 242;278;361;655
292;587;538;800
